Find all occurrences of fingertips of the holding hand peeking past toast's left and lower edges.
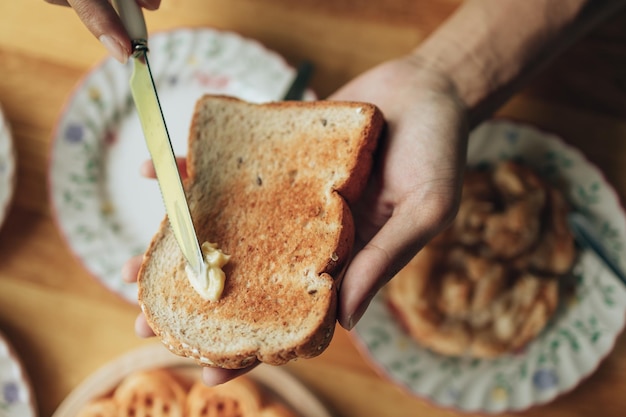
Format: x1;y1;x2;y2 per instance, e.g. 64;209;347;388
122;158;258;386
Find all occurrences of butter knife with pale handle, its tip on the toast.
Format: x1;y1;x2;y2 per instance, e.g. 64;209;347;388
113;0;204;275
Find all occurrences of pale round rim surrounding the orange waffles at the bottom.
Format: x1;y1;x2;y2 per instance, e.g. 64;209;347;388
52;343;330;417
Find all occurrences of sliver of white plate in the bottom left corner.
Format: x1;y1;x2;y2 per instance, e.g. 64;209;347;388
0;333;37;417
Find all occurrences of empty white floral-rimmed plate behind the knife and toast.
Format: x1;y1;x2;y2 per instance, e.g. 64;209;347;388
49;29;312;303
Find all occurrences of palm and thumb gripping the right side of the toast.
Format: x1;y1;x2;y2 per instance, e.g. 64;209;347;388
330;56;468;329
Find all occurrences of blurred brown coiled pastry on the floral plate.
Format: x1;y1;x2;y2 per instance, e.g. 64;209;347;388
385;161;576;358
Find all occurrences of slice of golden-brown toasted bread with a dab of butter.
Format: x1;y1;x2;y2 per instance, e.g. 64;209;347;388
138;96;384;368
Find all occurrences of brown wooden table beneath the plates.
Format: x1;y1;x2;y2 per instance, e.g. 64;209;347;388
0;0;626;416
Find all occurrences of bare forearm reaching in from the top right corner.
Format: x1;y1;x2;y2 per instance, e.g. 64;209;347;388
413;0;626;126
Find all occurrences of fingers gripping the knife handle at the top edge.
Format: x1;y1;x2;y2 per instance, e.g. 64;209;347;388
45;0;161;63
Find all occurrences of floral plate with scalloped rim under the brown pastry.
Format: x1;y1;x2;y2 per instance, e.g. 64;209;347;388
353;121;626;413
